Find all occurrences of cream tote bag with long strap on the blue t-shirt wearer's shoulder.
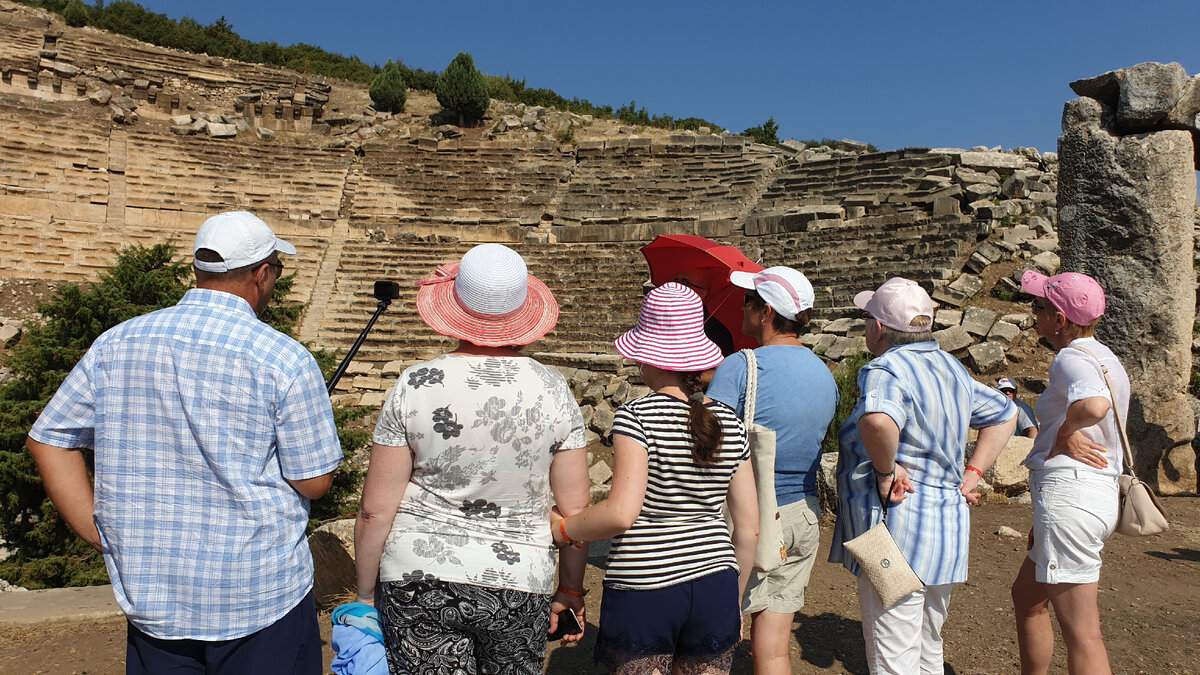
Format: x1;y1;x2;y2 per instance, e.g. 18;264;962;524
742;350;787;572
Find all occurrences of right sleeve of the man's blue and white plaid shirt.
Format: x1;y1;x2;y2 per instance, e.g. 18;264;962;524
275;354;342;480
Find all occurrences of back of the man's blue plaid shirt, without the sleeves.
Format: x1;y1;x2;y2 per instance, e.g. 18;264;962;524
82;288;328;640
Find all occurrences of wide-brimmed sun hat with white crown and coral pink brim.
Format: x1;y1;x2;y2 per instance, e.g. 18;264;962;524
416;244;558;347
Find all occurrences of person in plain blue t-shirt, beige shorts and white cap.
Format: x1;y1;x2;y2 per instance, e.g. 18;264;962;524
708;267;838;673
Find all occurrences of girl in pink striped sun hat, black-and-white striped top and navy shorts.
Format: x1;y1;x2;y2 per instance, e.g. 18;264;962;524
551;282;758;673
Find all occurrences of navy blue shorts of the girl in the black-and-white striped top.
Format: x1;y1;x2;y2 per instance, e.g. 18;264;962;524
595;569;742;673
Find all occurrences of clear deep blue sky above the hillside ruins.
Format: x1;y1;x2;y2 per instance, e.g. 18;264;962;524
131;0;1200;150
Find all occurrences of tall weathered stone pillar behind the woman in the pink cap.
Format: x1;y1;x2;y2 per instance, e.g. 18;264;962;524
1058;64;1196;494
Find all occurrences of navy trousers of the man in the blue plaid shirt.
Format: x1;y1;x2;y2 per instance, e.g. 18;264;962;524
125;591;322;675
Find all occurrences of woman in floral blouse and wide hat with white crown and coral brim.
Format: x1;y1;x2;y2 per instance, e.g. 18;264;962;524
354;244;588;675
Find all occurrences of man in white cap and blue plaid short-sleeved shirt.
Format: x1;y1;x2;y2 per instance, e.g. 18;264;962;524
26;211;342;674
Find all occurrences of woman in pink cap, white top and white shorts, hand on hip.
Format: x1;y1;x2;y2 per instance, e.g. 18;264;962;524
1013;270;1129;674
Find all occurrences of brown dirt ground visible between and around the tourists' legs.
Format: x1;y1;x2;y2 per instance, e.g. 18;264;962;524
0;497;1200;675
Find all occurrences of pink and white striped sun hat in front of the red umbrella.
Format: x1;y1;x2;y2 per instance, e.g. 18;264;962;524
613;281;725;372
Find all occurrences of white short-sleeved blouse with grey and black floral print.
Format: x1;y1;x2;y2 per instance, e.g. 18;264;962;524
373;354;586;593
